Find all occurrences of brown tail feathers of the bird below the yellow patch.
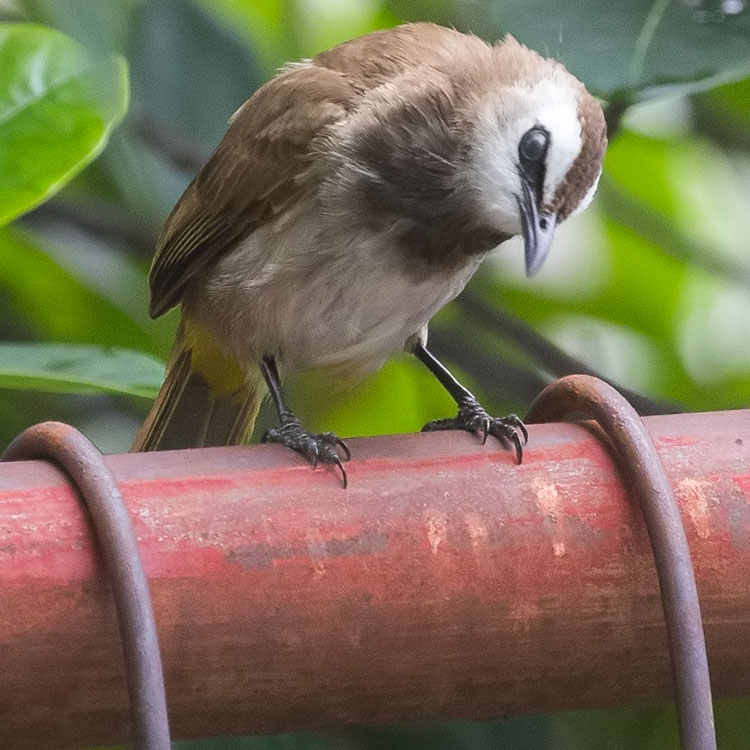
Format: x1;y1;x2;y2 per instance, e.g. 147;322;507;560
131;337;265;452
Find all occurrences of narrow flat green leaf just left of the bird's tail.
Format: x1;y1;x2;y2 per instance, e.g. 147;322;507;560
0;344;164;398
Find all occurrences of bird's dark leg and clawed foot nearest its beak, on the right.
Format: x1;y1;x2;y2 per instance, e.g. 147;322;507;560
412;343;528;464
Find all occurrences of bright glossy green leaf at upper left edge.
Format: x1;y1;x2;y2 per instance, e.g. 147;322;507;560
0;24;128;226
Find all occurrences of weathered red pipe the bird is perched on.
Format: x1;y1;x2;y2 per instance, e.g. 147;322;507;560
0;411;750;748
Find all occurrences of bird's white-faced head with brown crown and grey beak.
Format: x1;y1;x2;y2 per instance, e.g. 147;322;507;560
469;36;607;276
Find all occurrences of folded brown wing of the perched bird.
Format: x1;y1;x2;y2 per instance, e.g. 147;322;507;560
149;64;360;317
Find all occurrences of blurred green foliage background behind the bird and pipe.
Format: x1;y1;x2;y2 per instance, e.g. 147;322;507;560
0;0;750;750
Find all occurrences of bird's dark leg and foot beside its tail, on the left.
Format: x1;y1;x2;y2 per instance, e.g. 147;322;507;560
260;357;351;487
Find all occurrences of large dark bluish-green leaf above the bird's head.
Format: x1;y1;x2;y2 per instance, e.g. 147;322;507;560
392;0;750;99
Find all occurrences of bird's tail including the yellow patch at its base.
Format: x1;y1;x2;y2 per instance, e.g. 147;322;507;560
131;322;266;452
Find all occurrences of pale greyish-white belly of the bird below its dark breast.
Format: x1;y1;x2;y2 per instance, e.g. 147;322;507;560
187;217;481;373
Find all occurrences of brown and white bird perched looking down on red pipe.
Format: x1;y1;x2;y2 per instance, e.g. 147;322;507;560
133;23;607;487
